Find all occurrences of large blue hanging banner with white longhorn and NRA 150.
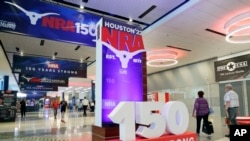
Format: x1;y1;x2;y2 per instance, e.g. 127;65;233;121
0;0;101;47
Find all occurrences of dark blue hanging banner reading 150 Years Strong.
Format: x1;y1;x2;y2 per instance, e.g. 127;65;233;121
12;55;87;77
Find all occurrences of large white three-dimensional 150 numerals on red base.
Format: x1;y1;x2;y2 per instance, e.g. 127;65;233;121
109;101;189;141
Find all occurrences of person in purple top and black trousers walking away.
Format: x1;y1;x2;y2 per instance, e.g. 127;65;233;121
193;91;211;139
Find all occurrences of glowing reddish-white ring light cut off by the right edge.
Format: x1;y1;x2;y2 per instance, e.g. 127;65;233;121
224;11;250;43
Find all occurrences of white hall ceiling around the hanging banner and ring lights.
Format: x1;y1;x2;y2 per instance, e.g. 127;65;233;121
0;0;250;93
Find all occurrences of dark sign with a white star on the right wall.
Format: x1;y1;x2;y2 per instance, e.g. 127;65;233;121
214;54;250;82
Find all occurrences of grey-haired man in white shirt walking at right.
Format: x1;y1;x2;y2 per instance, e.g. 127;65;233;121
224;84;239;137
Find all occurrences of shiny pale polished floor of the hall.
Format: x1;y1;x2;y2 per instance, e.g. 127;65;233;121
0;109;229;141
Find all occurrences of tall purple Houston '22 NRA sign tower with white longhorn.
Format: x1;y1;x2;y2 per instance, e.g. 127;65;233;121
96;18;145;126
